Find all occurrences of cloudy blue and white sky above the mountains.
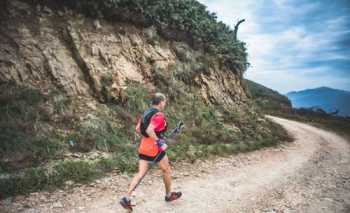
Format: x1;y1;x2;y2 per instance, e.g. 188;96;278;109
199;0;350;94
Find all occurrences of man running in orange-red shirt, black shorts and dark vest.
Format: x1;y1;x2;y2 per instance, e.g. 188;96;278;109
120;93;182;210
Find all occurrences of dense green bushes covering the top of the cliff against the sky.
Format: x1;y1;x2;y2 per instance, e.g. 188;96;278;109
37;0;249;73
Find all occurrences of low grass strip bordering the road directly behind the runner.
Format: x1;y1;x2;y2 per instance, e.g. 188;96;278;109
0;154;137;198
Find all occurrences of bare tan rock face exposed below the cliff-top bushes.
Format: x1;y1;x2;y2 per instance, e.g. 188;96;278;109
0;0;247;107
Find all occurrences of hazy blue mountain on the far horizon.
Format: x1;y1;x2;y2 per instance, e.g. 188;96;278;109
286;87;350;116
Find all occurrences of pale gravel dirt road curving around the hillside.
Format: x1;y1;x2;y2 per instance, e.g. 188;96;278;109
0;117;350;213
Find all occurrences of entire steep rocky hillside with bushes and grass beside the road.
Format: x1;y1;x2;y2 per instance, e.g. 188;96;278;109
0;0;289;198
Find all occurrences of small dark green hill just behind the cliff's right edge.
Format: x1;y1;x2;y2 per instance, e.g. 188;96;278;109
243;79;292;111
